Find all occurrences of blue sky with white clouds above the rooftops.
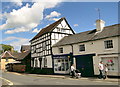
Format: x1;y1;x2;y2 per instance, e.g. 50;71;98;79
0;0;118;51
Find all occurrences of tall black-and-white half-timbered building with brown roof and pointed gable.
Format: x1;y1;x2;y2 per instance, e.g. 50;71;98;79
30;18;74;69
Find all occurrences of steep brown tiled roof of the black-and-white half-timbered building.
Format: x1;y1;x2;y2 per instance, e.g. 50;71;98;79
31;17;74;41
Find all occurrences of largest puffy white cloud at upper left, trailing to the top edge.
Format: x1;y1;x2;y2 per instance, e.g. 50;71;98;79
0;0;60;34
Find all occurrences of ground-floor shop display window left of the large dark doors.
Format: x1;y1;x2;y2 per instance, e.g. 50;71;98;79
54;59;69;71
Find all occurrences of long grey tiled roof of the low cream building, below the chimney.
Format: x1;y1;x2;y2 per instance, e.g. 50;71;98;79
53;24;120;47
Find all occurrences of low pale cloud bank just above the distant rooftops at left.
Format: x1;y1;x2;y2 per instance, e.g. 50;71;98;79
2;37;29;51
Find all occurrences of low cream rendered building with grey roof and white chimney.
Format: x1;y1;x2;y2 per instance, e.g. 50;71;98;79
52;20;120;76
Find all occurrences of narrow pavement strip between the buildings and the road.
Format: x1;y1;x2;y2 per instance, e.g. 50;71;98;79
7;72;120;83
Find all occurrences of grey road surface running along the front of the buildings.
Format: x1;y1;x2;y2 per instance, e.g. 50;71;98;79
2;72;118;87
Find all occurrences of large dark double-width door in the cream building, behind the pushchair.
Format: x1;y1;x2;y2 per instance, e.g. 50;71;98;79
75;55;94;77
